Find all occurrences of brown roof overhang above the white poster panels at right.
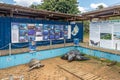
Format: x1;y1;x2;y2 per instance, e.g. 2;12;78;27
82;5;120;19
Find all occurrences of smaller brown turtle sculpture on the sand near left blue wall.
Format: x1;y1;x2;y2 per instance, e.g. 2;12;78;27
28;59;44;71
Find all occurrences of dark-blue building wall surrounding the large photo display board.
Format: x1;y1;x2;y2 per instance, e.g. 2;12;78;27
0;17;83;49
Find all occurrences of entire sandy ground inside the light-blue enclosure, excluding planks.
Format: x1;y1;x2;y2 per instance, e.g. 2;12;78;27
0;57;120;80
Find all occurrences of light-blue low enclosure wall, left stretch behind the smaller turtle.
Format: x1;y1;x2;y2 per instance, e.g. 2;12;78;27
0;47;74;69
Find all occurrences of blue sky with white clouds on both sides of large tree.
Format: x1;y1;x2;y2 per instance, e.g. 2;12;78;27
0;0;120;12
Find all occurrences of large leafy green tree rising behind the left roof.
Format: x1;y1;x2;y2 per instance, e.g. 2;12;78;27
30;0;80;14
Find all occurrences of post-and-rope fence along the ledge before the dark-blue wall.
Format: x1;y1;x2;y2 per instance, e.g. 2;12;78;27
0;39;76;56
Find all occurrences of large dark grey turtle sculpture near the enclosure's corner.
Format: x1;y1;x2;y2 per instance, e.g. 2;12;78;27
61;50;89;62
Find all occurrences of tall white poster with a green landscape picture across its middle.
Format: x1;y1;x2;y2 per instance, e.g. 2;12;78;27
100;21;113;49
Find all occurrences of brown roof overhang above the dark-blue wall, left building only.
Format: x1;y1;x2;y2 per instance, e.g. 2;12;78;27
0;3;83;21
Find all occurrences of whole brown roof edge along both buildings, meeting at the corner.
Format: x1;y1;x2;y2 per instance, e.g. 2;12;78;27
0;3;120;21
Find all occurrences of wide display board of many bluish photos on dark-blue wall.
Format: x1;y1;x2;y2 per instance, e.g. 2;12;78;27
11;23;71;43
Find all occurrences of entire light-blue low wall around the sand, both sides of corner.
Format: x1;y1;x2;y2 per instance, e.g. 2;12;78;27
0;46;120;69
